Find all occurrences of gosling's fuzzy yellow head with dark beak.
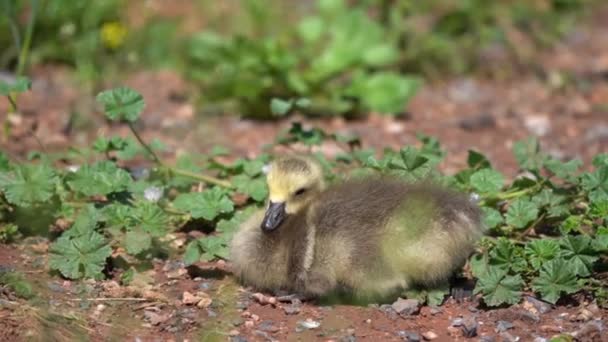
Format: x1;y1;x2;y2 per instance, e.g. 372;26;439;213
262;156;324;232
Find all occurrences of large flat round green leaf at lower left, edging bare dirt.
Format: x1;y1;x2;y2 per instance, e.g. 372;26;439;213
49;231;112;279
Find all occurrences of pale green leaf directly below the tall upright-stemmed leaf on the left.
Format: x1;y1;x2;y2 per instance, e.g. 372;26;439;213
68;161;133;196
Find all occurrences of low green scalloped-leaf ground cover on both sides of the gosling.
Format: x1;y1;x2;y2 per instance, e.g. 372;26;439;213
0;80;608;340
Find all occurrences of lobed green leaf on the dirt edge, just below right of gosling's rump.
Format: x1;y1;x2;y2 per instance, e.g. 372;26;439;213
475;267;524;306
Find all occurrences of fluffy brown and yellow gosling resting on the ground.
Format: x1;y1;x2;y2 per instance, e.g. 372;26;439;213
230;156;483;300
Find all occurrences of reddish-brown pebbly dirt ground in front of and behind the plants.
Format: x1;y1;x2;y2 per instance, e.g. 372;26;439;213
0;2;608;341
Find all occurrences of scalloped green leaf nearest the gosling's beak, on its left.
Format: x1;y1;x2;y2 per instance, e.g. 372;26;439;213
173;187;234;221
